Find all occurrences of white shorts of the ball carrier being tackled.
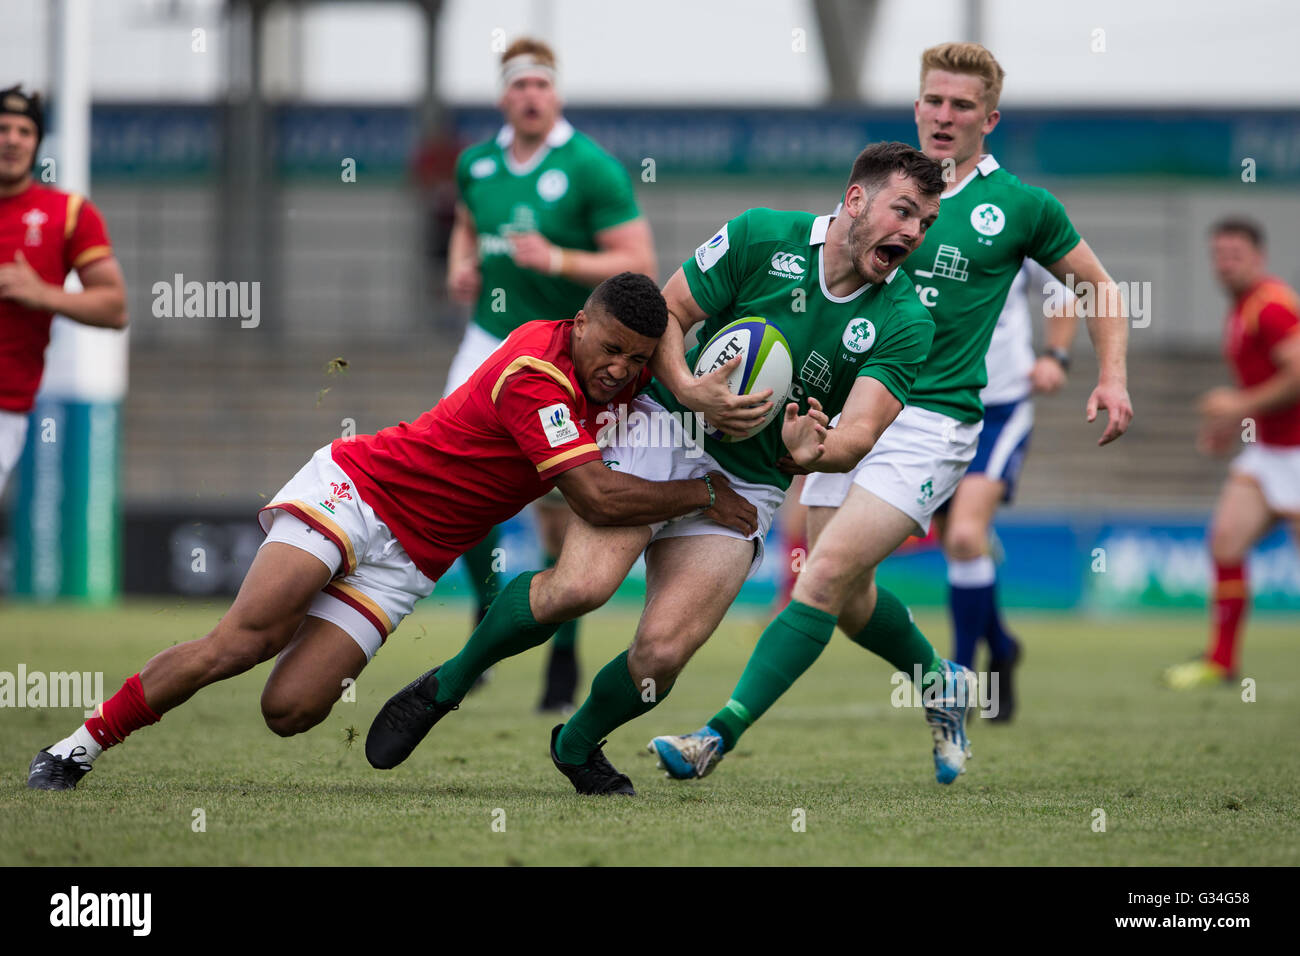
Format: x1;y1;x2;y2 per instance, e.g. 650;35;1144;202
597;394;785;578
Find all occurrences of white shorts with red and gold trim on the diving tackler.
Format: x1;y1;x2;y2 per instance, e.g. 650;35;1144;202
257;445;434;661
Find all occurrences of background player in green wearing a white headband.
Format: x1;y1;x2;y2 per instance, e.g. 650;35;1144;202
445;38;658;710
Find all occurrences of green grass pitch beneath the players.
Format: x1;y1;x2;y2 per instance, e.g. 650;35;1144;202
0;601;1300;866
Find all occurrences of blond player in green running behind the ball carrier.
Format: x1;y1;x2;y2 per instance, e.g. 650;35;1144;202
650;43;1132;783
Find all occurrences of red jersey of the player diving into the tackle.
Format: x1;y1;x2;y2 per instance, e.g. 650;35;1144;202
332;319;650;580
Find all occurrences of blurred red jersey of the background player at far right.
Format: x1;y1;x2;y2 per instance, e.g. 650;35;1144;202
1223;276;1300;446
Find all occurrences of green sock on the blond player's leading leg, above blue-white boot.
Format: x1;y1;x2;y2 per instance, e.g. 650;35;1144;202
709;601;835;752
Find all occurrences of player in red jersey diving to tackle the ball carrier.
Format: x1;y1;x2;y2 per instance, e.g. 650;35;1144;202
27;272;758;790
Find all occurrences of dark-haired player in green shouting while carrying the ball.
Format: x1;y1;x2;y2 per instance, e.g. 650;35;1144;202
367;143;944;795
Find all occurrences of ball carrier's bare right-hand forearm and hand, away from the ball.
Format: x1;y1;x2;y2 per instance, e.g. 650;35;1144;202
781;376;902;472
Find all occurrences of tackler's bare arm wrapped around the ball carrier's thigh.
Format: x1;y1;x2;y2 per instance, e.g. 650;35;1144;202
555;462;758;535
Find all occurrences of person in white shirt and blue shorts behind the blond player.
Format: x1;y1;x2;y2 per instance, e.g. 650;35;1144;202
935;259;1078;721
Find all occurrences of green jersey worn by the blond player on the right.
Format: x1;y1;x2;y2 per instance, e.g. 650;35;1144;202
906;156;1079;423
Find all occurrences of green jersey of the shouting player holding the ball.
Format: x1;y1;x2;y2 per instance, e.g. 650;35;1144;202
649;209;935;489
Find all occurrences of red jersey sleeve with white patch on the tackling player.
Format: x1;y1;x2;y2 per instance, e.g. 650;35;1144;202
493;368;601;481
